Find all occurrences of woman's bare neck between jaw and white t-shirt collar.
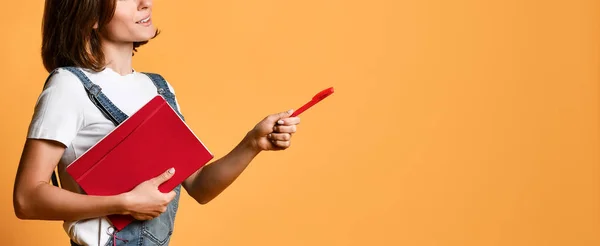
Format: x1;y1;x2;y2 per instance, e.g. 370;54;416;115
102;42;133;75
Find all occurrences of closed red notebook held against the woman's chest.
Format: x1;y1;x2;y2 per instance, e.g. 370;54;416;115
67;95;214;230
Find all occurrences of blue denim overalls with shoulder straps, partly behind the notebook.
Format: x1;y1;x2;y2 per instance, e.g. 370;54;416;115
53;67;184;246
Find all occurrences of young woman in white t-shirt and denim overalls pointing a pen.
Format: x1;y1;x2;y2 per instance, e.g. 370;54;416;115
14;0;300;245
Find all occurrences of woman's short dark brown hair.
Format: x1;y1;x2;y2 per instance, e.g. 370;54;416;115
42;0;159;72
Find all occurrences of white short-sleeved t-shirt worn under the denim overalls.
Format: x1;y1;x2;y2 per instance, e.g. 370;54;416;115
27;68;181;245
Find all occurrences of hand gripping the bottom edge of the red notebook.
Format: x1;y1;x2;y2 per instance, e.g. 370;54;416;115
124;168;176;220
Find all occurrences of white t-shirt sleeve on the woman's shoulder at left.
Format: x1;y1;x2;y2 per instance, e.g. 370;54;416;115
27;69;89;146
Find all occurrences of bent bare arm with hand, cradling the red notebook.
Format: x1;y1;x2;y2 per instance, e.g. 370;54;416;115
13;139;174;221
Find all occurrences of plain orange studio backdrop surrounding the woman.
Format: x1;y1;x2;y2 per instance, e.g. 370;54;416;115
0;0;600;246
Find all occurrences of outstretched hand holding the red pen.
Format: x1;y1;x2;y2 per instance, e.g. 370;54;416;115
248;110;300;151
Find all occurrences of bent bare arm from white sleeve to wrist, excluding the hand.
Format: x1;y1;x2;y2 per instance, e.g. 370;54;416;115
13;139;125;220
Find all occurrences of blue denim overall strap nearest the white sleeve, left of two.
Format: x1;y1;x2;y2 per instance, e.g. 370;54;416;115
64;67;128;125
